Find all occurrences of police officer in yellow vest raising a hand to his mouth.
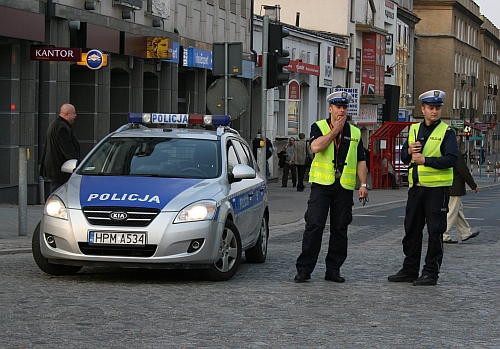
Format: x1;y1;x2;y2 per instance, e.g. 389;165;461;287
295;91;370;282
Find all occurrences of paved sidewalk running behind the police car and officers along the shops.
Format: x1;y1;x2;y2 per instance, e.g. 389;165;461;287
0;171;500;255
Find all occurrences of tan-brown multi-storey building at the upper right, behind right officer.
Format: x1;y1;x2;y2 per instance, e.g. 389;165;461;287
414;0;500;153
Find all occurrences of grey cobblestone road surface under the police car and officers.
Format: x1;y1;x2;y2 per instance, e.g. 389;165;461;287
0;219;500;348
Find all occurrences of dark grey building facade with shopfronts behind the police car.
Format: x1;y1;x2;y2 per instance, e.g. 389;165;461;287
0;0;254;203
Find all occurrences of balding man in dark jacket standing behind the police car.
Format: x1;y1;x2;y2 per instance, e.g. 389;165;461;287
40;104;80;193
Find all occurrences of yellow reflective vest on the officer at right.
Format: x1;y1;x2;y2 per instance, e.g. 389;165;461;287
408;122;453;187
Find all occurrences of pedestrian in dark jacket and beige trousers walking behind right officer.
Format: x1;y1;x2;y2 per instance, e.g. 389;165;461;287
443;136;479;244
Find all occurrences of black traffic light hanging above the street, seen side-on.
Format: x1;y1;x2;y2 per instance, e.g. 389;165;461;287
267;23;290;88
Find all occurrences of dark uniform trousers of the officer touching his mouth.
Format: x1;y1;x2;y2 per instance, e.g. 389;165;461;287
296;180;354;273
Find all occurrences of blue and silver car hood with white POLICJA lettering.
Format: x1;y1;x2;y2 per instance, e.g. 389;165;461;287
67;175;221;211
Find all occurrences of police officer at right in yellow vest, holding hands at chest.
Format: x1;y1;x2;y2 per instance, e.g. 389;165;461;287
388;90;458;286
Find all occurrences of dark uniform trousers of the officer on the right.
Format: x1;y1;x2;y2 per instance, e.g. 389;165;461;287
401;186;450;280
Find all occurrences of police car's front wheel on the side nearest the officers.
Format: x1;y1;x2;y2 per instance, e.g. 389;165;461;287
202;220;241;281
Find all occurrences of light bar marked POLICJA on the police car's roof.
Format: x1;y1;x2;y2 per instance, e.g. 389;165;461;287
128;113;231;126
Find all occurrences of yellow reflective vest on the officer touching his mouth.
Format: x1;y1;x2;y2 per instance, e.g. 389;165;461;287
309;120;361;190
